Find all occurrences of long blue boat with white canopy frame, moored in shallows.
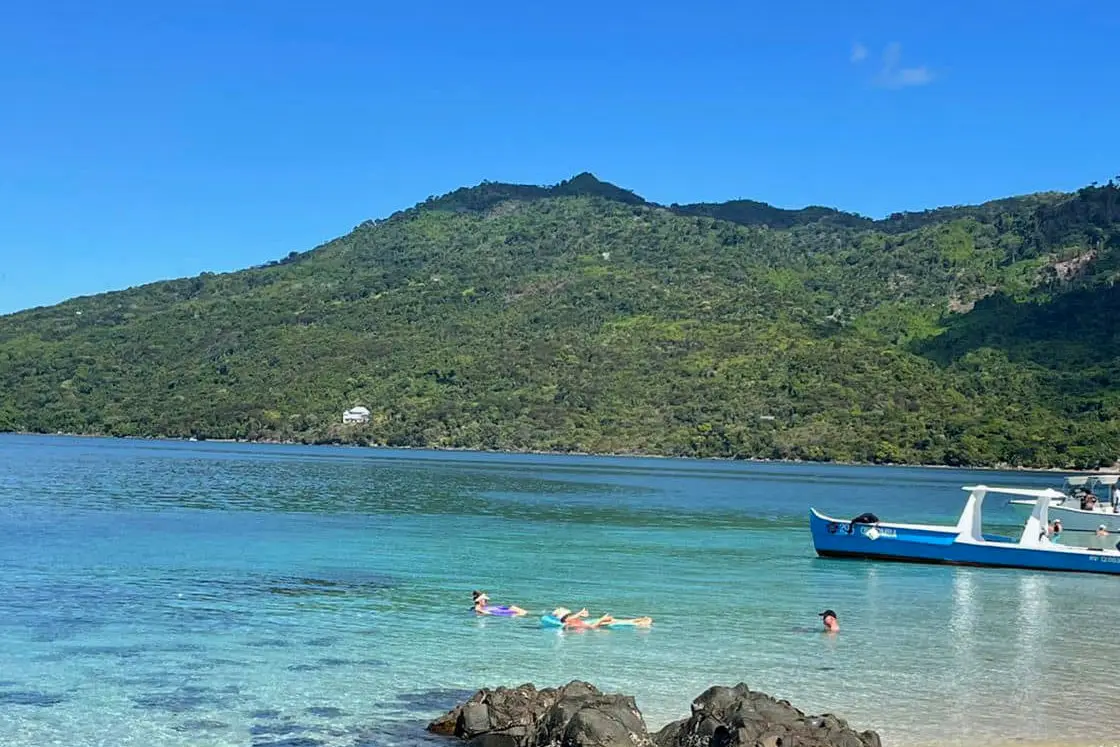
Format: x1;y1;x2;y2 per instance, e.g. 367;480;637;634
809;485;1120;575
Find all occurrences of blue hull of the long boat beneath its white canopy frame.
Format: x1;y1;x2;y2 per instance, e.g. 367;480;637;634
810;510;1120;575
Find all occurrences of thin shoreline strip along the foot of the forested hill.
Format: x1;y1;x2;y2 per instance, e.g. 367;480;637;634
0;430;1106;472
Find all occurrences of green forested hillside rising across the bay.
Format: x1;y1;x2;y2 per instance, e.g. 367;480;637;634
0;175;1120;467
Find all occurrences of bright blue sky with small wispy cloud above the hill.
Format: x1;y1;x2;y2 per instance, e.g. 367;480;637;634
0;0;1120;314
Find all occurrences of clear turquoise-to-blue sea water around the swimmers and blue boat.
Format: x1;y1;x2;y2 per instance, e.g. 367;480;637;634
0;436;1120;747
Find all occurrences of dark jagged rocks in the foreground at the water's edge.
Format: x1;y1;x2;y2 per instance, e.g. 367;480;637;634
428;681;881;747
